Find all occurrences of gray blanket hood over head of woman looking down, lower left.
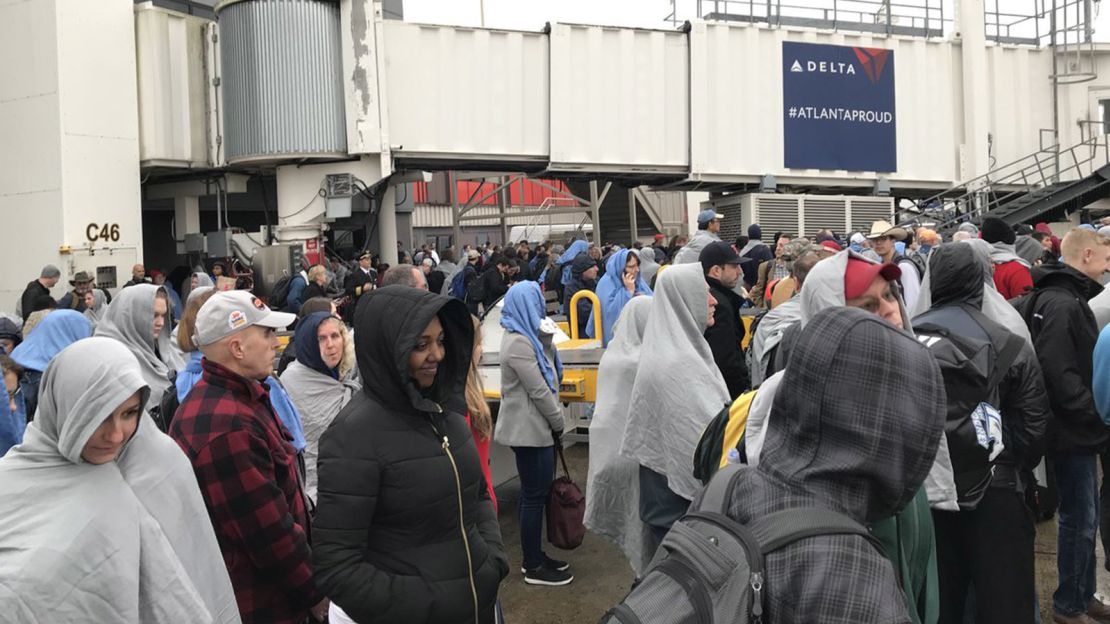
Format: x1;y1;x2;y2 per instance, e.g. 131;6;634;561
26;338;150;464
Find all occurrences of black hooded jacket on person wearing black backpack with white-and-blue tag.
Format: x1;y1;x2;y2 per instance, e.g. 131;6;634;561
914;244;1051;470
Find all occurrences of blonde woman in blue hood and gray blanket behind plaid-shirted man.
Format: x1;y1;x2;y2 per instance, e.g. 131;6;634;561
281;312;362;503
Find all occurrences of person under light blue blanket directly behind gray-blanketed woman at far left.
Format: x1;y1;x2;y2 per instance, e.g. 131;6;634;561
11;310;92;422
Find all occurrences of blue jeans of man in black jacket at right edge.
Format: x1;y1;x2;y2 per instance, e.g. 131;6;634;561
1052;454;1099;616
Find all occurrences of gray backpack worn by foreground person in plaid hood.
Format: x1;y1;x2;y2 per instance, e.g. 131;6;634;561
601;464;882;624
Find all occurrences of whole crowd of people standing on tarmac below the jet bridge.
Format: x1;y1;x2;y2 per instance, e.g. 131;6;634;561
0;210;1110;624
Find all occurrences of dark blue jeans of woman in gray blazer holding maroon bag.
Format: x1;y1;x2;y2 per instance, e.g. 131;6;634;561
513;446;555;570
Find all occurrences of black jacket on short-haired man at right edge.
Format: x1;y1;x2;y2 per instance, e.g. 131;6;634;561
1016;262;1110;453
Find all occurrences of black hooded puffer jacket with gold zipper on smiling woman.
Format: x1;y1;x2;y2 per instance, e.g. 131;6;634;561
312;286;508;624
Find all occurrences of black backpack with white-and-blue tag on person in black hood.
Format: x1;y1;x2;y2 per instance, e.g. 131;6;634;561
914;311;1025;510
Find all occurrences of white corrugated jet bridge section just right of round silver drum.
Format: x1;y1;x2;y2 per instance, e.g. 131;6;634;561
384;20;549;160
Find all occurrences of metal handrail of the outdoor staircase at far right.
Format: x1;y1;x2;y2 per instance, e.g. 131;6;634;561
902;131;1110;229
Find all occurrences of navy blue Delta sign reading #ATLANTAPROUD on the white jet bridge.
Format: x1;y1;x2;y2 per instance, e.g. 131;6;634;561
783;41;898;172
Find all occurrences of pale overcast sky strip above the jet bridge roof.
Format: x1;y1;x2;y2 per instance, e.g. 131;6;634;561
404;0;1110;41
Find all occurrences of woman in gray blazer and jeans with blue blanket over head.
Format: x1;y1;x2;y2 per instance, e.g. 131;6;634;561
493;282;574;585
